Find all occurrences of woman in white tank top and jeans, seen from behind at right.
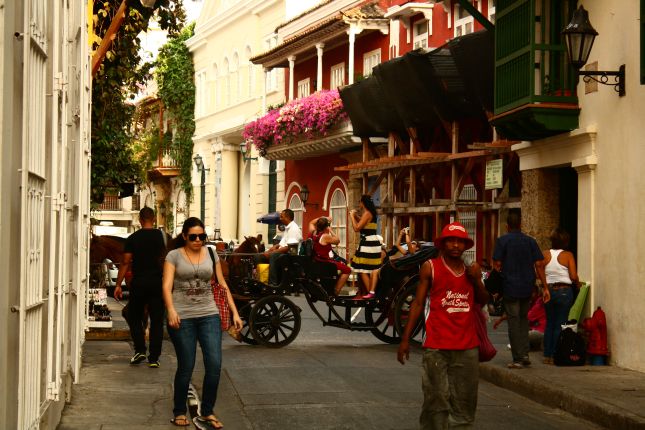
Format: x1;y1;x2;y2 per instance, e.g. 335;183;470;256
542;227;578;364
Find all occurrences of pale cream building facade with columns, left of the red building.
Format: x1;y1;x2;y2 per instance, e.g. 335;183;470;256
187;0;286;241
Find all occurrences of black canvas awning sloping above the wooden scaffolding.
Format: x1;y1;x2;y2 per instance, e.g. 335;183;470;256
340;31;494;137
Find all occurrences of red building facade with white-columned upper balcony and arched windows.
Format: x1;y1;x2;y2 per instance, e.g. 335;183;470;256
252;0;500;258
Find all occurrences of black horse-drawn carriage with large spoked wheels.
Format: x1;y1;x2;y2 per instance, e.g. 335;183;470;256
220;238;436;348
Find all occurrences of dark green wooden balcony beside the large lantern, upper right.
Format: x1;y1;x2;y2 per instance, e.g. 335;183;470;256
491;0;580;140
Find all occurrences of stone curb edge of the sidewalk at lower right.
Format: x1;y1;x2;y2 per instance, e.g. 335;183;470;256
479;364;645;430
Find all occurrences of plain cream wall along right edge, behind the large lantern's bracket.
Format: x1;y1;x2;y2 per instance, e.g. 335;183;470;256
578;0;645;371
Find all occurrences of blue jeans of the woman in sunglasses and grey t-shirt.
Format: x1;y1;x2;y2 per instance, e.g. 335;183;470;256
168;314;222;416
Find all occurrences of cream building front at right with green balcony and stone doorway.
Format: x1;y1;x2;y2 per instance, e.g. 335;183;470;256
492;0;645;371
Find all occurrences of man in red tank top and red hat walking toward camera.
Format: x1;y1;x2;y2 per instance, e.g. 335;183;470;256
397;222;488;430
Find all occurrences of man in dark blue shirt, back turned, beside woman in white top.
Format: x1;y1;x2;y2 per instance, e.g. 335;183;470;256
493;210;548;369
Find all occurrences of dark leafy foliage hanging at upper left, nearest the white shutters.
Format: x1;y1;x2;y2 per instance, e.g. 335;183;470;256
91;0;185;203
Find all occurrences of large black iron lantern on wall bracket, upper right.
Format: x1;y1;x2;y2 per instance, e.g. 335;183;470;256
562;6;625;97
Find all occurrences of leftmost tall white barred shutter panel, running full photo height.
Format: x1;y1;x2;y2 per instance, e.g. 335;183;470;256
18;0;47;430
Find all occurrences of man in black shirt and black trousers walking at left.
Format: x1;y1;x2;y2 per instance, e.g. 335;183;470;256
114;207;166;368
